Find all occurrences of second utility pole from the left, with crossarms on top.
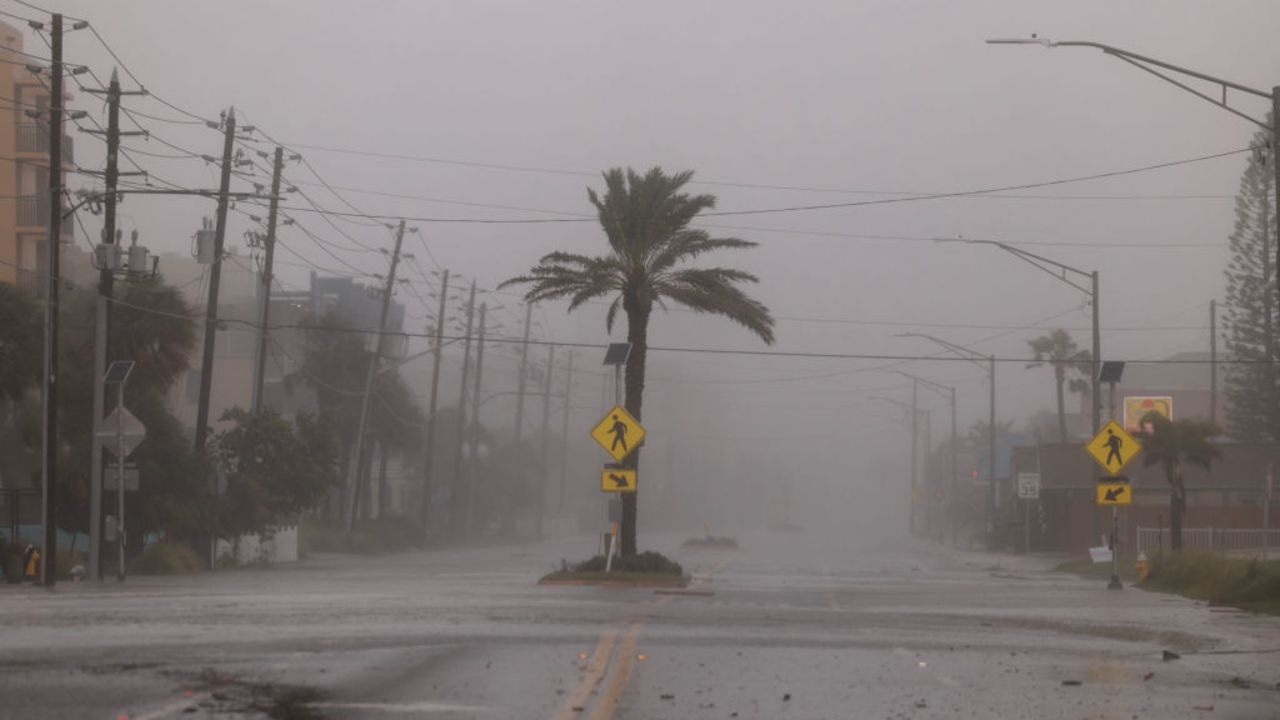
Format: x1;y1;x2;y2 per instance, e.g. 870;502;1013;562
83;69;146;580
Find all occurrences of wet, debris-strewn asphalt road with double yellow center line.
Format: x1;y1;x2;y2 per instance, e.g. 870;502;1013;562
0;532;1280;720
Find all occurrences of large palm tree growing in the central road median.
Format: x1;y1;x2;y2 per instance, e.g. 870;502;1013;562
503;168;773;555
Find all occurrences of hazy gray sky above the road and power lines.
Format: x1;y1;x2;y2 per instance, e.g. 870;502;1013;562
30;0;1280;527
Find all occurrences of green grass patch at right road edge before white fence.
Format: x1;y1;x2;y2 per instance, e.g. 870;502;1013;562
1142;552;1280;614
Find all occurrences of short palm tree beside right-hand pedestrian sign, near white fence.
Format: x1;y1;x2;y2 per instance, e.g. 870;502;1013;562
1138;410;1222;551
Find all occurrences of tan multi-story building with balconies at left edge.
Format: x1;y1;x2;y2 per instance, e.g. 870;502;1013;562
0;22;74;296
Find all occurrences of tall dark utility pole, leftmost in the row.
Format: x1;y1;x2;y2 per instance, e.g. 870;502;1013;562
40;13;63;588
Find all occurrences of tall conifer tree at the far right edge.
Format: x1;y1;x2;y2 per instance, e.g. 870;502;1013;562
1222;112;1280;442
